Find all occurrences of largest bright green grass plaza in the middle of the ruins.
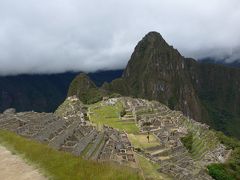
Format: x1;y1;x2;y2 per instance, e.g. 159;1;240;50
90;102;139;133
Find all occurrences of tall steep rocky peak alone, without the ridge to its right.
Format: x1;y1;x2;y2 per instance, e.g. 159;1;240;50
105;32;205;120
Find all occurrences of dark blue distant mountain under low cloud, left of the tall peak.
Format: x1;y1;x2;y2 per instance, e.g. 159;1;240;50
0;70;123;112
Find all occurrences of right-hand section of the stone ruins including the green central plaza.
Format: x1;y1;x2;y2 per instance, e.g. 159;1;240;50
88;97;231;179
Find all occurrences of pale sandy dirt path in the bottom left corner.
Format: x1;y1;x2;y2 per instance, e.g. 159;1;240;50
0;145;47;180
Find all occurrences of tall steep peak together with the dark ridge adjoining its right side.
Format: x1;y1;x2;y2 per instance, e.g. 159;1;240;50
95;32;240;138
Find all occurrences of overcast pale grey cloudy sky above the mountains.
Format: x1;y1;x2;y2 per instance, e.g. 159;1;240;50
0;0;240;75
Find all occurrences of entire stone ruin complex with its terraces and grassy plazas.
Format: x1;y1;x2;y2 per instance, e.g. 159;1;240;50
0;97;231;180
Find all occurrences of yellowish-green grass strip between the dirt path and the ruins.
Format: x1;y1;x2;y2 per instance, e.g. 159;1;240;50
0;130;141;180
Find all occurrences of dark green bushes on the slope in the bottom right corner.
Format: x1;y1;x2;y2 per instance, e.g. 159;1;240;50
208;132;240;180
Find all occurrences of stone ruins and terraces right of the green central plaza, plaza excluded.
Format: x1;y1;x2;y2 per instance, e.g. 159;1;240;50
119;98;232;179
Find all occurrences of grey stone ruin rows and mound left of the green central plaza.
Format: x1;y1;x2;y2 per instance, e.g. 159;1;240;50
0;98;138;167
